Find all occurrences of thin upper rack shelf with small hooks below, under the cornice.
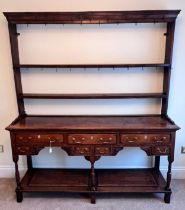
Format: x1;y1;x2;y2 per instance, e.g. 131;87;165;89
15;63;171;69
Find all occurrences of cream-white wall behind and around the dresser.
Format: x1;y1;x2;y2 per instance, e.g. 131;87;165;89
0;0;185;178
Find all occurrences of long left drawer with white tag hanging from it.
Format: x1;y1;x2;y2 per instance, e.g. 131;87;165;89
16;133;63;146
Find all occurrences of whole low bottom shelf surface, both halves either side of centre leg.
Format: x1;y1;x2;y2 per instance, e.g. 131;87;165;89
21;169;169;193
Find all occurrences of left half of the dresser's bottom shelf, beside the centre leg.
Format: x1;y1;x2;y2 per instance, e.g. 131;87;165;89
21;169;90;192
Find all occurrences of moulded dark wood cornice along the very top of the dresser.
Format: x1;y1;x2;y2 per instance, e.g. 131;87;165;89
4;10;180;24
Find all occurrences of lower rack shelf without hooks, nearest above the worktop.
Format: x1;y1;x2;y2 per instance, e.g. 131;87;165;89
19;93;167;99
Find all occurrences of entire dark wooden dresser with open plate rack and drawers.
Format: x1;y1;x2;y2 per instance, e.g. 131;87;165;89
4;10;180;203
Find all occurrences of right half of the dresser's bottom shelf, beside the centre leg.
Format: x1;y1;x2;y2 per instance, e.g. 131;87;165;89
95;168;166;192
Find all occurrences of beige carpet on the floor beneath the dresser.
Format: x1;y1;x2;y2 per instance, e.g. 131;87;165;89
0;179;185;210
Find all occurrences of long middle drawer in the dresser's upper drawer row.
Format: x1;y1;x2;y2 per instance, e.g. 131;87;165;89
67;134;116;144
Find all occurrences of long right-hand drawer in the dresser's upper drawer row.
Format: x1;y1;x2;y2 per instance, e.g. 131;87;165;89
121;134;170;146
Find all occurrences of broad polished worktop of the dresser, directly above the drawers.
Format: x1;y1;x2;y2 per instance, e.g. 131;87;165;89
6;115;179;130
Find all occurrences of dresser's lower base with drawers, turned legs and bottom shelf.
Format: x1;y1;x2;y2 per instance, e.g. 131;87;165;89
7;115;178;203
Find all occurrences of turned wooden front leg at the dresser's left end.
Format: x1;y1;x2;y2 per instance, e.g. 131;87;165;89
13;155;23;203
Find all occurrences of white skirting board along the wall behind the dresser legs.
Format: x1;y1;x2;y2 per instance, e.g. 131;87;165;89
0;166;185;179
